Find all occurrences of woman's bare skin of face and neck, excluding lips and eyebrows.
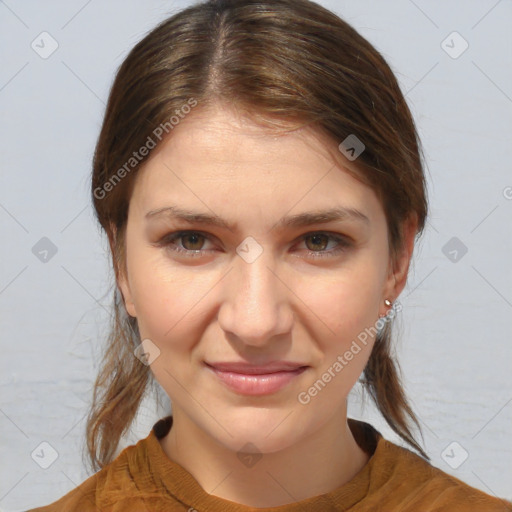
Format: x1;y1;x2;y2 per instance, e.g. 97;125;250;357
118;105;415;507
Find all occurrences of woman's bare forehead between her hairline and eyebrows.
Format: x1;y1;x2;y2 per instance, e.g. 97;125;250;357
127;107;380;228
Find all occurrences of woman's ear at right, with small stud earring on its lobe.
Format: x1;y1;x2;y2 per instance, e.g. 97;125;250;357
380;215;418;315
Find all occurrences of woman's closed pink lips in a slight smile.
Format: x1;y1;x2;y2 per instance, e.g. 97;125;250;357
205;361;308;396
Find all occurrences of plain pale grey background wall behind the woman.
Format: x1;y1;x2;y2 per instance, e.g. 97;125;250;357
0;0;512;511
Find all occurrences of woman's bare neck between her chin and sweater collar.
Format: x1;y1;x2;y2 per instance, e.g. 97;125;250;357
160;409;369;508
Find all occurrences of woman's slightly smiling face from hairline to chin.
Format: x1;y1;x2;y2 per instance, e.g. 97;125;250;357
120;103;408;452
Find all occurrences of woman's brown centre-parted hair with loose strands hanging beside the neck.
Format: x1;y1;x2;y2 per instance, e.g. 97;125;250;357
86;0;430;471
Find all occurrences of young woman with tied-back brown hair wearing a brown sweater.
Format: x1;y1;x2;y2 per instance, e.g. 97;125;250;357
29;0;512;512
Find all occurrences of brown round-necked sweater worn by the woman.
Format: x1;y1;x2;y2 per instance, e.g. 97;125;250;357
28;416;512;512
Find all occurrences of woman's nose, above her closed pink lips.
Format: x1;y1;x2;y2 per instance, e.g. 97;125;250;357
218;251;293;347
